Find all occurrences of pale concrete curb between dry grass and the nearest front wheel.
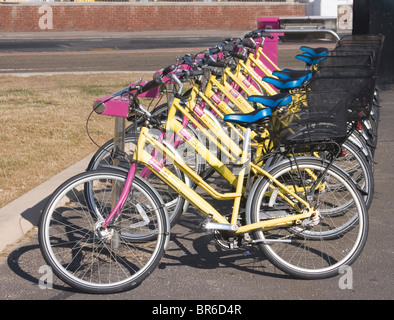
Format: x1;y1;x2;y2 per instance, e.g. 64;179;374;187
0;155;92;252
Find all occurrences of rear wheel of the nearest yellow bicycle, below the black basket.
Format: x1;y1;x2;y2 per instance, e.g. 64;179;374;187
247;157;368;279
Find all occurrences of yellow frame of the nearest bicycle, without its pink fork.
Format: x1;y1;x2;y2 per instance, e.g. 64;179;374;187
133;124;315;233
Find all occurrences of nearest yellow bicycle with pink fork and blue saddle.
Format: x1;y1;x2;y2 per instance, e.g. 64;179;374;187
39;70;368;293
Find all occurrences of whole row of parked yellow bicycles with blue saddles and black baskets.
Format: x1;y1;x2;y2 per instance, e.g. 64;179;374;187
39;30;384;293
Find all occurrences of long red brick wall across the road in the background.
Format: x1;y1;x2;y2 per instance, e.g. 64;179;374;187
0;2;305;32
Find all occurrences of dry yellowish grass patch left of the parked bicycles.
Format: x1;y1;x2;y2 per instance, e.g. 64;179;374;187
0;73;154;208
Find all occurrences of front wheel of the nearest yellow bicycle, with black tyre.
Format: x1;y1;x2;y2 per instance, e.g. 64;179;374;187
38;169;169;293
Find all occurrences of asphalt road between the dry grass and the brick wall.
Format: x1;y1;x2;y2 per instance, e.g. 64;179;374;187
0;30;333;75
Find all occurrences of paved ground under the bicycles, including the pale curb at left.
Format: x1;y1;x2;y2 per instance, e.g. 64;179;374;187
0;33;394;300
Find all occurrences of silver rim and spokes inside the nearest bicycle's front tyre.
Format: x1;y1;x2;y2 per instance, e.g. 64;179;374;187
43;175;163;289
